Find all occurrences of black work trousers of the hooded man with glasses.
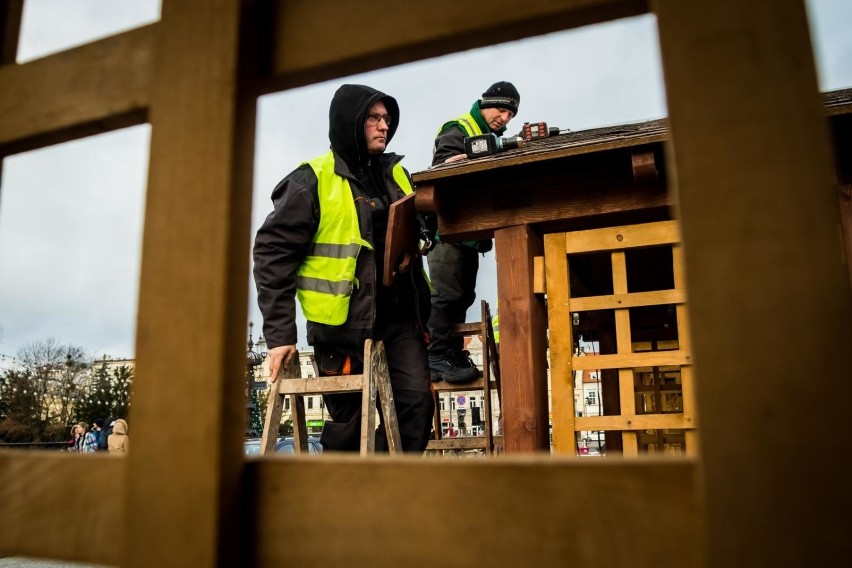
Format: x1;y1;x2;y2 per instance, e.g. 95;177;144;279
315;322;435;453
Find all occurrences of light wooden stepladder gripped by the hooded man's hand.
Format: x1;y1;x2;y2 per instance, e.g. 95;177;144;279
260;339;402;456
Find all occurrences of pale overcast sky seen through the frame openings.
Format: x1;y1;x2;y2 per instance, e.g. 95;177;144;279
0;0;852;367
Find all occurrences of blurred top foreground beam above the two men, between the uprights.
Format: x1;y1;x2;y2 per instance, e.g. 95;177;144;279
266;0;648;91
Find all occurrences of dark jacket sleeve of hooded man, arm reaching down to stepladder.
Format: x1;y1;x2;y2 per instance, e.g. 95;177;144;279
254;166;319;348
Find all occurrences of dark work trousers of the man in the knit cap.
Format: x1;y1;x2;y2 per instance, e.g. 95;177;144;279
426;243;479;355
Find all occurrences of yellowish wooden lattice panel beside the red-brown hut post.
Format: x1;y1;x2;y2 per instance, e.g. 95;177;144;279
544;221;698;456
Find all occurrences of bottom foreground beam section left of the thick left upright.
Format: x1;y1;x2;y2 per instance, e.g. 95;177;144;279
0;447;124;565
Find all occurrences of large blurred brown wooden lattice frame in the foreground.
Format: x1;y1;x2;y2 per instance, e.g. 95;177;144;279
0;0;852;568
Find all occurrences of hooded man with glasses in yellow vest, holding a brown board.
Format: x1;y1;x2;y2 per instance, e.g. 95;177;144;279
254;85;434;452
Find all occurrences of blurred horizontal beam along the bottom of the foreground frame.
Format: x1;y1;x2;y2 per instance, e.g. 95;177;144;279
0;451;701;568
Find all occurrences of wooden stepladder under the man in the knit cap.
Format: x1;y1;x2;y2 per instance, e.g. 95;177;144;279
426;300;502;456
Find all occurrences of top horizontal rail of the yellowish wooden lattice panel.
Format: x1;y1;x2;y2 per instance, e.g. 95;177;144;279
565;221;680;253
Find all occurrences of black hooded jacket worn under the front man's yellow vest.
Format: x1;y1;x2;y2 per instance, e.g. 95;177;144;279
254;85;430;354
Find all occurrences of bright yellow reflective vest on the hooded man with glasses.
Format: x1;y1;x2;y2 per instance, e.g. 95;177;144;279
296;152;412;325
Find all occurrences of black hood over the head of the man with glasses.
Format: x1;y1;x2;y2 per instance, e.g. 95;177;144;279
328;84;399;167
